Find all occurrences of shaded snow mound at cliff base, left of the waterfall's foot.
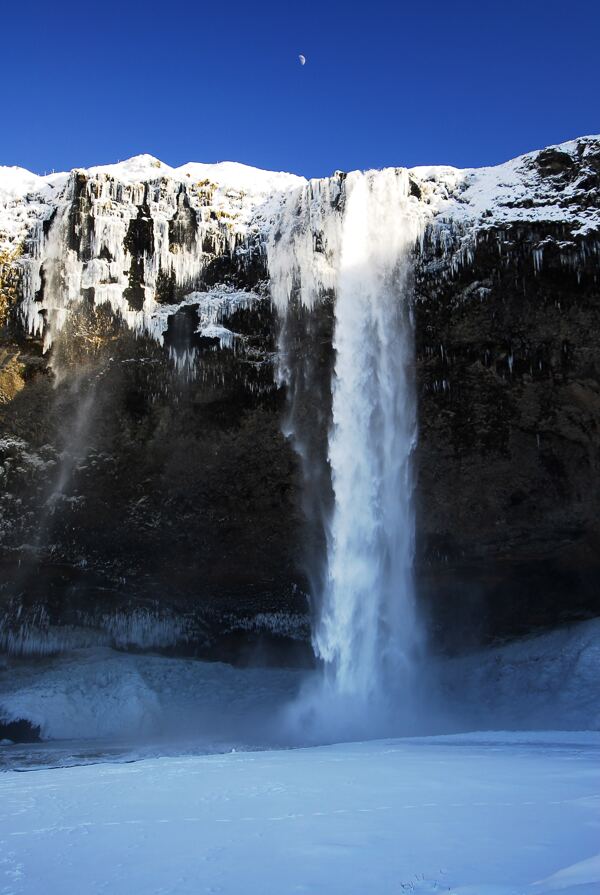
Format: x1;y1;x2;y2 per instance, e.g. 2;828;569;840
0;648;300;743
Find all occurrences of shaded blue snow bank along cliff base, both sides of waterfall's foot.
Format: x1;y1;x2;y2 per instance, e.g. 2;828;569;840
0;619;600;748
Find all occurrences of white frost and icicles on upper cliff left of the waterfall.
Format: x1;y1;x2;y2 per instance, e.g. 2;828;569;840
0;156;303;358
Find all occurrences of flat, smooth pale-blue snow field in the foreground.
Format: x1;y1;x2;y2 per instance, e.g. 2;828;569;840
0;733;600;895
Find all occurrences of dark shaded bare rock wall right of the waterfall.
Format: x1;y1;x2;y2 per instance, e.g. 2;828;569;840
416;224;600;643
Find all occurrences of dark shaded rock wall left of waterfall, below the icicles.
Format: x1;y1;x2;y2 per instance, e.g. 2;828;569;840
0;301;307;658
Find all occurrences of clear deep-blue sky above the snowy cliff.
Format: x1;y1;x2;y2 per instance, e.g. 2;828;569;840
0;0;600;176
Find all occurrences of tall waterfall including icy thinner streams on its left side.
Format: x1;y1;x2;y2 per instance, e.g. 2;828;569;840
268;169;427;736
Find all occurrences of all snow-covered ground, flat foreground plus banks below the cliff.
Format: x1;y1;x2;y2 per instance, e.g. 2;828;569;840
0;620;600;895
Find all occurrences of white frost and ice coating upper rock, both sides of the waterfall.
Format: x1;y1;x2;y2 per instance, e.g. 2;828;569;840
0;136;600;358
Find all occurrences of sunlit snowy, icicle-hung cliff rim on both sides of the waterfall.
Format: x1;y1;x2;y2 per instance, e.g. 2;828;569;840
0;136;600;356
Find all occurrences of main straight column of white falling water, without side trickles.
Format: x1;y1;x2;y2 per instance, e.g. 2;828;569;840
315;171;417;698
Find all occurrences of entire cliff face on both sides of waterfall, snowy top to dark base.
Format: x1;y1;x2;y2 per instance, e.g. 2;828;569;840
0;138;600;657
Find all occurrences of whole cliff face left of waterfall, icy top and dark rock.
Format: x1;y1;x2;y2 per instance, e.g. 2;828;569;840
0;158;307;654
